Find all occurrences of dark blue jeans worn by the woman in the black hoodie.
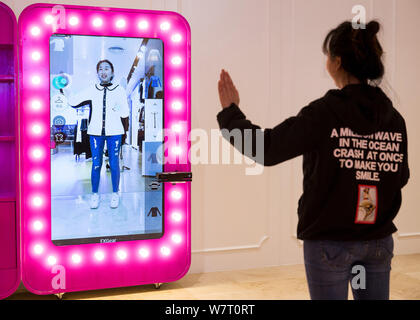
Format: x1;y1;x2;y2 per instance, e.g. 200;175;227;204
303;235;394;300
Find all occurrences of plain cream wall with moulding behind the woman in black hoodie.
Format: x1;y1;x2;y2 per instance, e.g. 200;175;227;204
5;0;420;272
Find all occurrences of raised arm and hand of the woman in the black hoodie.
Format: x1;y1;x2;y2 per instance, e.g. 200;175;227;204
217;70;328;166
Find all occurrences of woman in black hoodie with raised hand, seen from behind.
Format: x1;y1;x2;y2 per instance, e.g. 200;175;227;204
217;21;410;300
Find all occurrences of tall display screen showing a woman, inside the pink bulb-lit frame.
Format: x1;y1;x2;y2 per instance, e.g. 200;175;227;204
50;35;164;246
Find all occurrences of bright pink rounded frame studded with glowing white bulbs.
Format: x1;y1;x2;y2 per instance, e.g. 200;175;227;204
18;4;191;294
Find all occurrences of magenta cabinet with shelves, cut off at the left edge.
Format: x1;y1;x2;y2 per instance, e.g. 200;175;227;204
0;2;20;299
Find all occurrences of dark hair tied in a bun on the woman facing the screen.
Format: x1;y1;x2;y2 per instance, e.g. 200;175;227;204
322;20;385;82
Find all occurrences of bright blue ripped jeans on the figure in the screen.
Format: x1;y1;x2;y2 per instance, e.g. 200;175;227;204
89;135;122;193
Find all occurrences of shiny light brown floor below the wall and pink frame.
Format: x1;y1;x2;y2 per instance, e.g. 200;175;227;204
8;254;420;300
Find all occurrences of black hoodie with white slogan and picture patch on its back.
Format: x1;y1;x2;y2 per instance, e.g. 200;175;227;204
217;84;409;241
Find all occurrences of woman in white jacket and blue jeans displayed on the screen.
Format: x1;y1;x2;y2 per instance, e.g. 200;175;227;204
63;60;129;209
